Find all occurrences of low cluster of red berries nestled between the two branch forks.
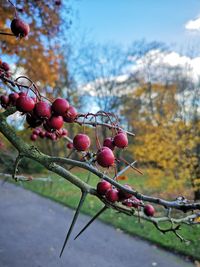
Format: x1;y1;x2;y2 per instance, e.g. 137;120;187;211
97;180;155;217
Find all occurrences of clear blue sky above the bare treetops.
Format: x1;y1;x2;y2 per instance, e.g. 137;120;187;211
73;0;200;51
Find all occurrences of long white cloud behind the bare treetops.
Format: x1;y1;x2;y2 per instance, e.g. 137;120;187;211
81;49;200;96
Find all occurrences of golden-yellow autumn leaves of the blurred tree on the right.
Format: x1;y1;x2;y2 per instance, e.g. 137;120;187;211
125;84;200;199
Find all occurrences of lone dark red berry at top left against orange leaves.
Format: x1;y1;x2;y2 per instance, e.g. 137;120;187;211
10;19;30;37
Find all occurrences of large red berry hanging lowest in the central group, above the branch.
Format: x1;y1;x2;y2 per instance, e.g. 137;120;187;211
97;146;115;167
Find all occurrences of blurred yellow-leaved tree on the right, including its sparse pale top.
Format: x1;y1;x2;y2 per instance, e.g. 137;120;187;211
120;44;200;199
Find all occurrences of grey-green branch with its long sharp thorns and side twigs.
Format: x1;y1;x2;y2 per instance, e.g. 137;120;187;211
0;75;200;255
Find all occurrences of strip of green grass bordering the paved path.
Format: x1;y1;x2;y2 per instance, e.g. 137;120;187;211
2;171;200;260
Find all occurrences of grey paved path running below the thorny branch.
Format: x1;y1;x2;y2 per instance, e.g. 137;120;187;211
0;184;194;267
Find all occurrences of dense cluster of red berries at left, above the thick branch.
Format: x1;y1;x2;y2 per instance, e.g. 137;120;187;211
0;92;77;141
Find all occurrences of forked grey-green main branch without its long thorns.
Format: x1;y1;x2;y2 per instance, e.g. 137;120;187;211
0;95;200;248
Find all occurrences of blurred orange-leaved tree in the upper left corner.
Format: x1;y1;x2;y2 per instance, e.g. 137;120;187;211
0;0;71;86
